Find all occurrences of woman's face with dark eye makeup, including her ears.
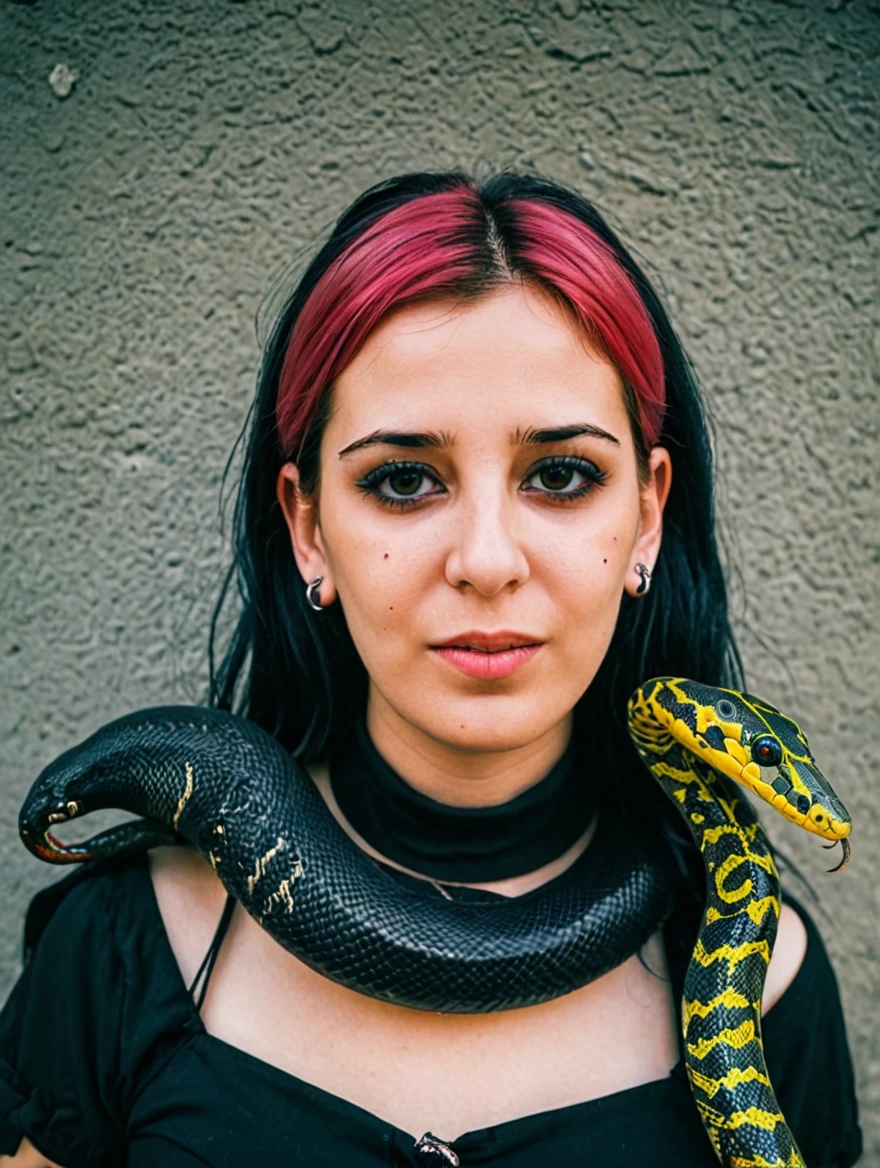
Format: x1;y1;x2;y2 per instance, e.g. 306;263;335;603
279;285;670;775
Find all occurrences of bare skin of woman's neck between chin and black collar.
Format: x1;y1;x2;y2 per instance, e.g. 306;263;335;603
366;688;573;807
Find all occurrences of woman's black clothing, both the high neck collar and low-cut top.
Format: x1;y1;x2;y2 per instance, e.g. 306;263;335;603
0;725;861;1168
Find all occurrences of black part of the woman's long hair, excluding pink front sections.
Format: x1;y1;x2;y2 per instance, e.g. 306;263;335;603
210;171;742;929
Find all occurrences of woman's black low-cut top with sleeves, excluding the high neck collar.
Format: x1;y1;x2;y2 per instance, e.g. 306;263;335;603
0;855;861;1168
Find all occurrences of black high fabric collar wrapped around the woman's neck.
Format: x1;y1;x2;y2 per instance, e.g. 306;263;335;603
330;716;597;883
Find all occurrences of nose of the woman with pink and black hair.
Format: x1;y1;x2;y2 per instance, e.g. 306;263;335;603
446;492;529;597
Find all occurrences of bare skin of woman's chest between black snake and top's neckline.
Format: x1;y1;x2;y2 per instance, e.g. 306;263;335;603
202;912;678;1139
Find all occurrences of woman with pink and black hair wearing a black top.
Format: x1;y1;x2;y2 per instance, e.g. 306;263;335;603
0;172;860;1168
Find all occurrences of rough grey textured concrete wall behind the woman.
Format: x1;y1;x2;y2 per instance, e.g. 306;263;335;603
0;0;880;1164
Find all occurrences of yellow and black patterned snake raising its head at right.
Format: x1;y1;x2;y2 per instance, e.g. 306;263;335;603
628;677;850;1168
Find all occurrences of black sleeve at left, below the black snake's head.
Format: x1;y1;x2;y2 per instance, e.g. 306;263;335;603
0;854;188;1168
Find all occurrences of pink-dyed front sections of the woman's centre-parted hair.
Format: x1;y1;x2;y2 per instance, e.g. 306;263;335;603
276;185;665;457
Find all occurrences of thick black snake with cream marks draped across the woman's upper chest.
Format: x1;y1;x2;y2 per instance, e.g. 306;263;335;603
19;707;674;1014
